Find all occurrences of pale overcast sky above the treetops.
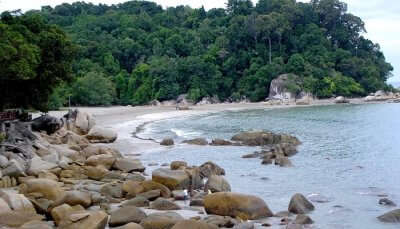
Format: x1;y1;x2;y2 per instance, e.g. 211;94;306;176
0;0;400;81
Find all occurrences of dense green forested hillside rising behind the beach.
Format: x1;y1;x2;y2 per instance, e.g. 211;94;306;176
28;0;392;105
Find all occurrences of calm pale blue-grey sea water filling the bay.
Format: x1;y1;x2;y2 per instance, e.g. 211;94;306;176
137;104;400;229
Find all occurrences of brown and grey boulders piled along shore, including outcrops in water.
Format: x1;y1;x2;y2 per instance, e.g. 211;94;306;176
0;100;400;229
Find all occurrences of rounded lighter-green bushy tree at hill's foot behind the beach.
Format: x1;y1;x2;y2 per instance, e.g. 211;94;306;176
72;72;116;106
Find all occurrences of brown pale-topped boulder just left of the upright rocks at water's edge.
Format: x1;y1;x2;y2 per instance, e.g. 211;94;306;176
152;168;190;190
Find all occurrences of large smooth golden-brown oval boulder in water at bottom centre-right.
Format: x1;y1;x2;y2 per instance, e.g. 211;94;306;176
204;192;273;220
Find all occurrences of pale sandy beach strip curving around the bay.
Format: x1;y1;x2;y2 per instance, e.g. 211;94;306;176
51;98;366;156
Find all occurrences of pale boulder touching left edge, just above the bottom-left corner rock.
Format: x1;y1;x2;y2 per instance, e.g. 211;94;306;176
0;190;36;214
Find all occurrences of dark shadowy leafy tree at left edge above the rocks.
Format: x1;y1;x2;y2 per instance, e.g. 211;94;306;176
0;12;74;111
